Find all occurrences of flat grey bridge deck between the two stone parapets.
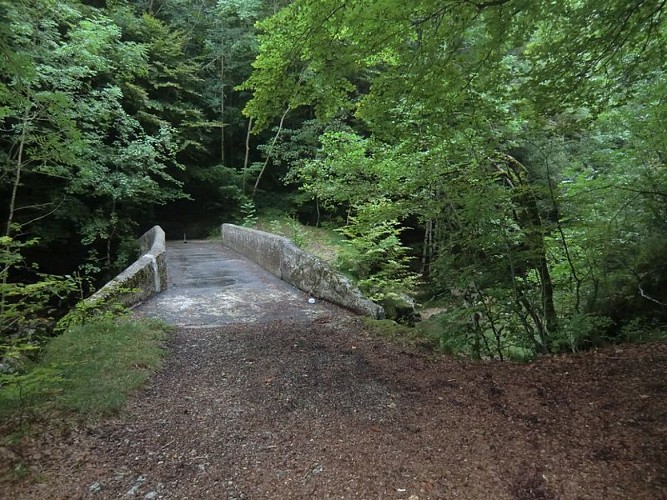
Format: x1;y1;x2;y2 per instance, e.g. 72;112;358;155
135;241;337;327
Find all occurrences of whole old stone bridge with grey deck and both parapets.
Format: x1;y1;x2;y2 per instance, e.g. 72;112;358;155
88;224;384;327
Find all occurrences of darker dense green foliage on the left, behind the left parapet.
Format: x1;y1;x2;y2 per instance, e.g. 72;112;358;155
0;0;280;348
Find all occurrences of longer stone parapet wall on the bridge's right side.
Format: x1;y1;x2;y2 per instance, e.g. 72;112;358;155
222;224;384;319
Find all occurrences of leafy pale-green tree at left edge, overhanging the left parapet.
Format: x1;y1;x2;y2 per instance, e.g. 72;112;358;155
0;1;188;340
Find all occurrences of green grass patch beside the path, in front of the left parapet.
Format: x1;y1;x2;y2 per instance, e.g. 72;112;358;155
0;318;167;422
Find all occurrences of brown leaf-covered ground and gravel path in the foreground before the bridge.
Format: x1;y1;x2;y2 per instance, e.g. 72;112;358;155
0;309;667;500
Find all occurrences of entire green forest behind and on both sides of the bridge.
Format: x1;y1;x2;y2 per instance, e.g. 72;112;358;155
0;0;667;359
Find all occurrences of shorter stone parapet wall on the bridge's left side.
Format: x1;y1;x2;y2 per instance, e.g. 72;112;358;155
85;226;167;307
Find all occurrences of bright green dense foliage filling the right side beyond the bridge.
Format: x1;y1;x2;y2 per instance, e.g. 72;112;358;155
243;0;667;358
